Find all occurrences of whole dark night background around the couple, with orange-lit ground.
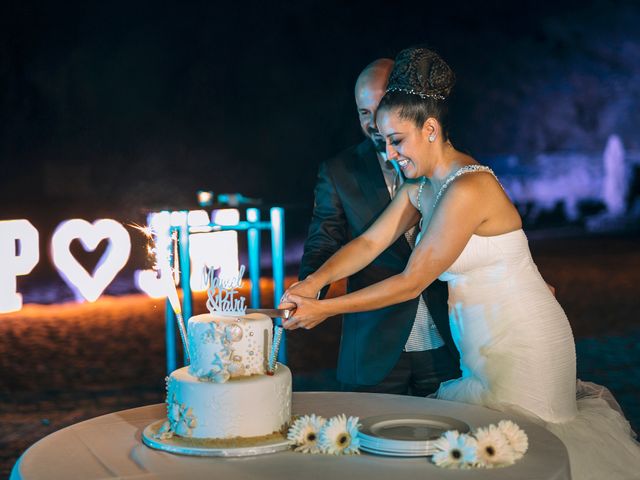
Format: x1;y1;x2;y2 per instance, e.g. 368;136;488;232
0;0;640;477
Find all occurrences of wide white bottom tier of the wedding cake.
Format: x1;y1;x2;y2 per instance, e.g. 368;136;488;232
167;364;291;439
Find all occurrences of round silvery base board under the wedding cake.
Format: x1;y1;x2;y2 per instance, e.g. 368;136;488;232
142;419;291;457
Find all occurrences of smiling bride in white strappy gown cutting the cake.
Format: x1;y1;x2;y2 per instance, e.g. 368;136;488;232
281;48;640;479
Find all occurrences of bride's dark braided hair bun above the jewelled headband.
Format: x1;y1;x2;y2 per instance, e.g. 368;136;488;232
387;47;456;100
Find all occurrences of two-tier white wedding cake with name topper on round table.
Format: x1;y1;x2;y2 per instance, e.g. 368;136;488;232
158;268;291;440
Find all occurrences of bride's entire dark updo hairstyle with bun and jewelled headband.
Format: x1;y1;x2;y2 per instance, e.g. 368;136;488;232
378;47;456;141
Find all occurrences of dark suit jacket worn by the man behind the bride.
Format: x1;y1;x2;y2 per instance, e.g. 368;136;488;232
299;140;459;385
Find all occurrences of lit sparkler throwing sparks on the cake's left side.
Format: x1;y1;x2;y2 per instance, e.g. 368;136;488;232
131;224;190;363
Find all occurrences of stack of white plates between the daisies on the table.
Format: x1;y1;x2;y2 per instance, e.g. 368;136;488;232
358;413;469;457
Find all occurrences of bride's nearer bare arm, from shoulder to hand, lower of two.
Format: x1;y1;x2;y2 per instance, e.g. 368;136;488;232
286;175;490;328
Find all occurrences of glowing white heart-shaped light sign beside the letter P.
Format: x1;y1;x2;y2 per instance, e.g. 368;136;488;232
51;219;131;302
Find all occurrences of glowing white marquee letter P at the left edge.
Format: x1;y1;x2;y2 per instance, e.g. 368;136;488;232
0;219;40;313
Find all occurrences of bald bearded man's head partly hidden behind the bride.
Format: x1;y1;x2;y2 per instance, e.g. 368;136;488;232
354;58;393;152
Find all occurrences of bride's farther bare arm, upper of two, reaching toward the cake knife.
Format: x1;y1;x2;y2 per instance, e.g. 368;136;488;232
283;184;419;298
